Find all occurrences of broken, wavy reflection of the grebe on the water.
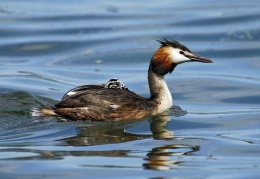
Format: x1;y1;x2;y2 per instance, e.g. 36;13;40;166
62;107;200;170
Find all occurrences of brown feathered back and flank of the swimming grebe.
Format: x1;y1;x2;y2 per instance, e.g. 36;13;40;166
42;88;156;121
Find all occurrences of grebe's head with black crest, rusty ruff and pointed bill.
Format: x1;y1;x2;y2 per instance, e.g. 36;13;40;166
150;39;213;75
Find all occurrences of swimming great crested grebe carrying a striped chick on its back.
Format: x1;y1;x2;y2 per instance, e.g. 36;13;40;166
34;39;213;121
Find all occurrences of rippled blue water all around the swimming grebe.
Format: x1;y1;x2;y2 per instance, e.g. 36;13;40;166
0;0;260;178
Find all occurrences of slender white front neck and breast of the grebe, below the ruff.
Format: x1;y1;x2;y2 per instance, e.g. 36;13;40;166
148;67;173;113
